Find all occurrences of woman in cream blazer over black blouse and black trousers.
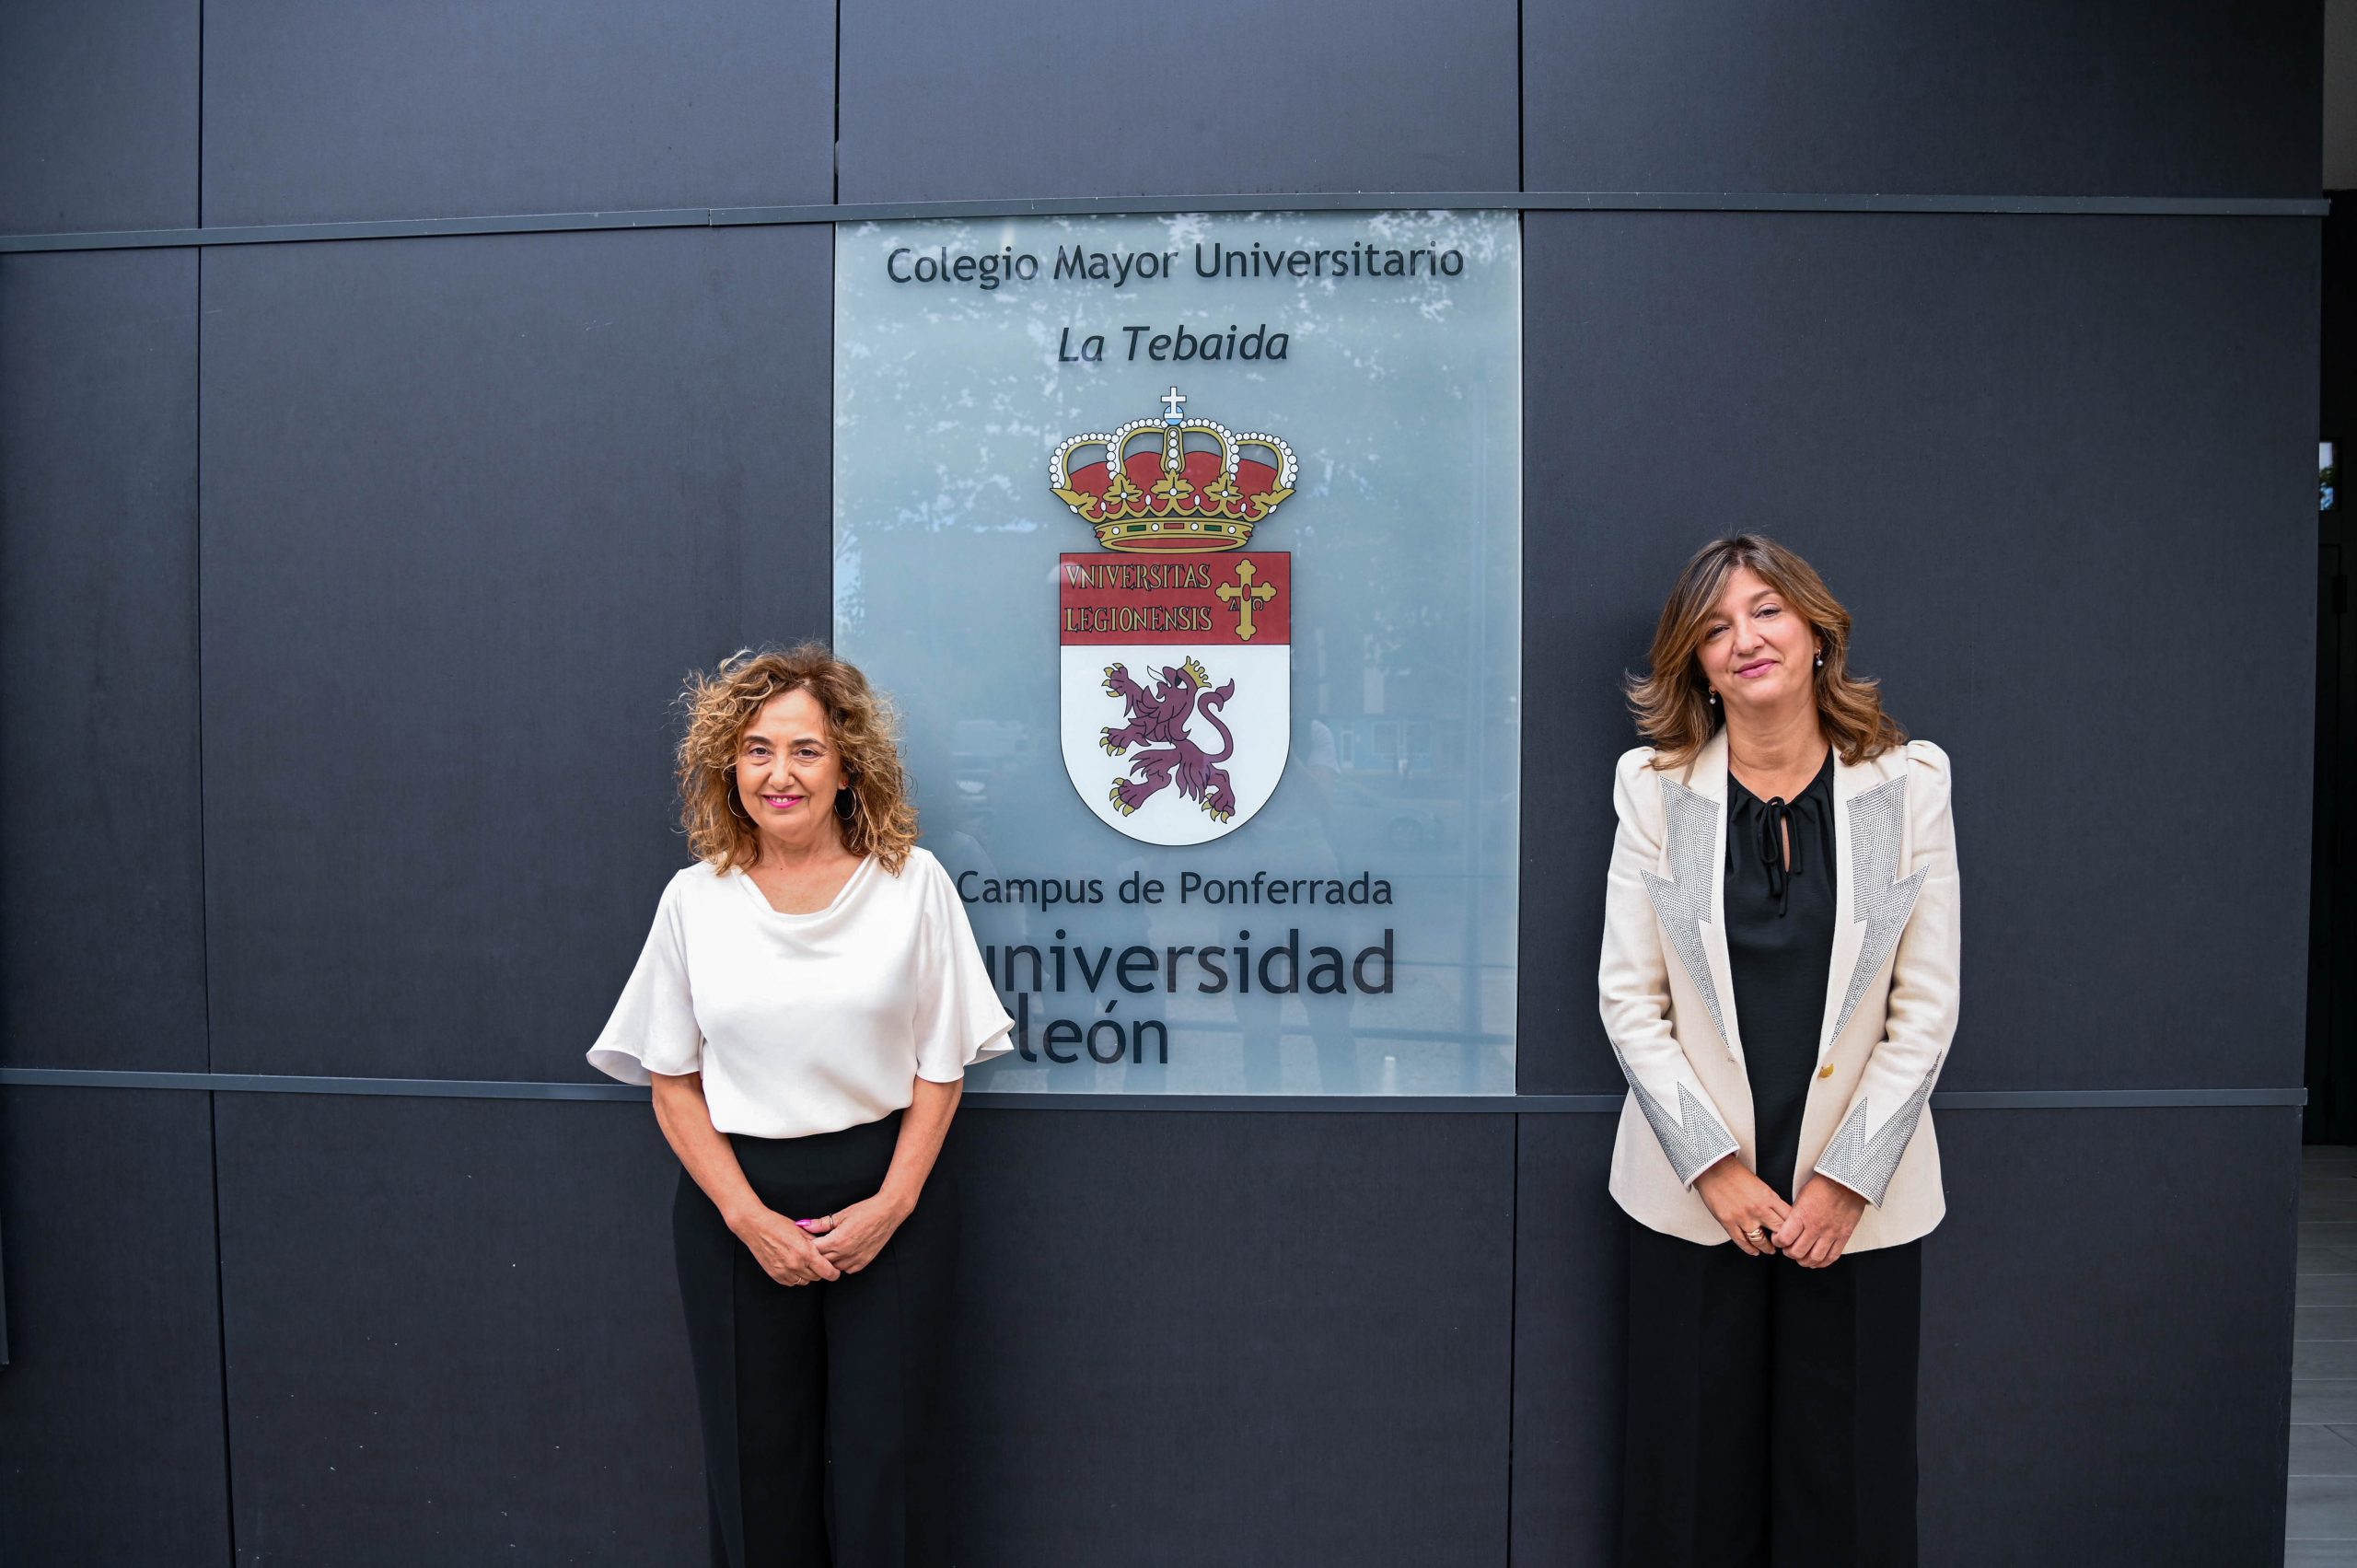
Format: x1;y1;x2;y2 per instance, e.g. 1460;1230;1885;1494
1598;535;1958;1568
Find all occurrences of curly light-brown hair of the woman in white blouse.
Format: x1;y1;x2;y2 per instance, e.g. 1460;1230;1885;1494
679;642;917;875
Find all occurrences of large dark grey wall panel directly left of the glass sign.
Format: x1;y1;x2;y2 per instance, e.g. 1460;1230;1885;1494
203;226;832;1077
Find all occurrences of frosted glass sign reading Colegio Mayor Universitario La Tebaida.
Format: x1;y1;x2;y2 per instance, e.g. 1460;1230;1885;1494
834;212;1523;1094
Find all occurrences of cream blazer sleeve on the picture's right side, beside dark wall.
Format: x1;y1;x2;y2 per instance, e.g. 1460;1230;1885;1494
1815;740;1963;1207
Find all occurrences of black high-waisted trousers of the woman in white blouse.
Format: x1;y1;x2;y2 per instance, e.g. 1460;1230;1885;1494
672;1113;957;1568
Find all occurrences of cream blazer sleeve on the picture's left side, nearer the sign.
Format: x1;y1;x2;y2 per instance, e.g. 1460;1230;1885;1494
1596;748;1737;1186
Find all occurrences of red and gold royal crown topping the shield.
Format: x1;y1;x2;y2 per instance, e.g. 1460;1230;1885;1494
1047;387;1294;554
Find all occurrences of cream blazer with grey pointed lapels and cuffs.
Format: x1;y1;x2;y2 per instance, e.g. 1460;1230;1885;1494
1596;731;1958;1252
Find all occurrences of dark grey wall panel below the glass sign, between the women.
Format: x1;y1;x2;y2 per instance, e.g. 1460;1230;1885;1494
947;1110;1518;1568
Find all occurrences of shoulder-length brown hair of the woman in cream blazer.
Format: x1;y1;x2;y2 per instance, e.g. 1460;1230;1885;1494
1629;533;1907;769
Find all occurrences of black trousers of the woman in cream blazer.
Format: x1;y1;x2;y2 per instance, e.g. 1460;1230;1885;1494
1620;1222;1923;1568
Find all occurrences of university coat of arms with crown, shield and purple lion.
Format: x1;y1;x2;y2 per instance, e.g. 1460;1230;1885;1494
1049;387;1294;844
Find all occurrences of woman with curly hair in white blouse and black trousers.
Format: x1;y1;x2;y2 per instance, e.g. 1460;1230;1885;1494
589;644;1011;1568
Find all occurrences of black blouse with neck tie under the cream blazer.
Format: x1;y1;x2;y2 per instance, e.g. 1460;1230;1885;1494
1725;752;1839;1200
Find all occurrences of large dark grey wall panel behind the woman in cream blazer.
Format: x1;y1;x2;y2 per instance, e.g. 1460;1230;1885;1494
1520;212;2316;1092
